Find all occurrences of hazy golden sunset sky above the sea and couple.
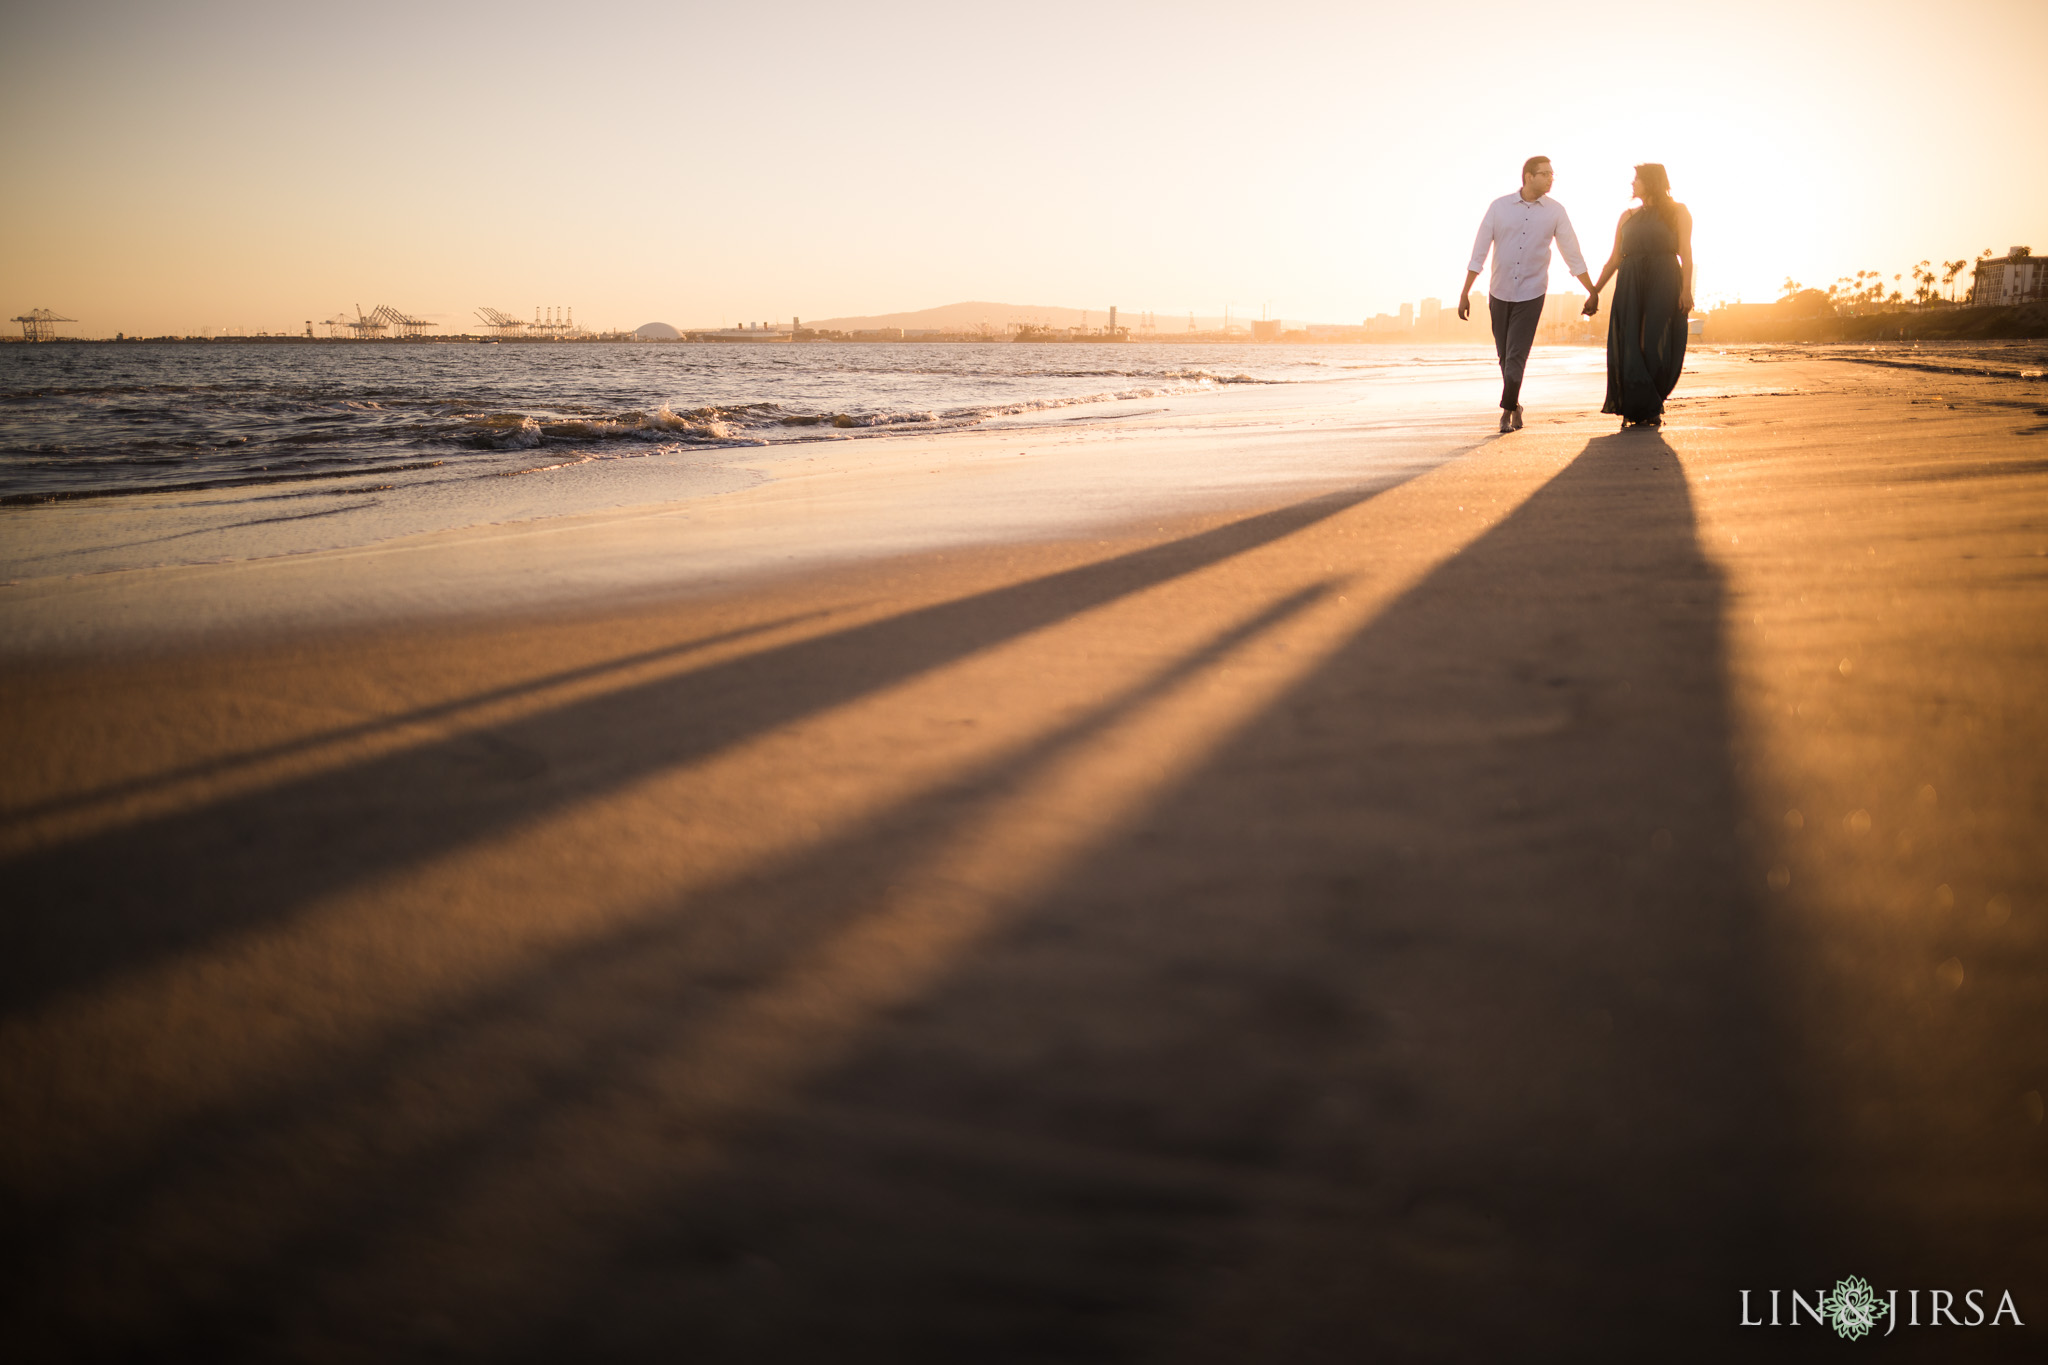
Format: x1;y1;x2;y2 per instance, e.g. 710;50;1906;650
0;0;2048;336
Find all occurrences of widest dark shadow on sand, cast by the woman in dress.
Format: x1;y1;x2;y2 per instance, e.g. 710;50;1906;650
516;432;1810;1361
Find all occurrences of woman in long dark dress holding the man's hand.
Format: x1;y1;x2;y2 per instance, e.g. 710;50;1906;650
1585;162;1692;432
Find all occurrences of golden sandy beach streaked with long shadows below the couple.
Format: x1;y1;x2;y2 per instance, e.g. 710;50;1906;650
0;352;2048;1363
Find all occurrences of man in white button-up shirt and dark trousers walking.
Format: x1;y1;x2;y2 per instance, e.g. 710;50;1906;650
1458;156;1595;432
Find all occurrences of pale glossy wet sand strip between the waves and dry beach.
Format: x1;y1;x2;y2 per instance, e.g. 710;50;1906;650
0;347;1613;657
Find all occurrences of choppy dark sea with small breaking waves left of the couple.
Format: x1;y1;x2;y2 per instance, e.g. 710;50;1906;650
0;344;1415;505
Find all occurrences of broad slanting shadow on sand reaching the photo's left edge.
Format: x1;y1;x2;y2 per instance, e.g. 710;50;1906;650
0;487;1378;1013
